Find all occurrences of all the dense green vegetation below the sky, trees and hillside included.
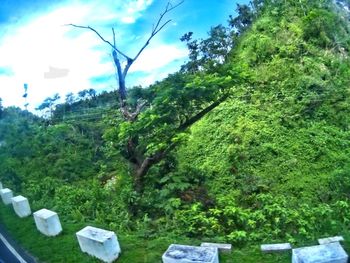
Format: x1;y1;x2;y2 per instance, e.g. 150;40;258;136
0;0;350;262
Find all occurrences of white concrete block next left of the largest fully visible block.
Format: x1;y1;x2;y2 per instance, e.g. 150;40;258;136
33;209;62;236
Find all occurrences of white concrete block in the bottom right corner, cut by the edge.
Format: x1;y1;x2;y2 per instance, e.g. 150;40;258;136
292;243;348;263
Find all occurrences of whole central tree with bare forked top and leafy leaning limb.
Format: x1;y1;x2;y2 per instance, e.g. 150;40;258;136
70;1;237;192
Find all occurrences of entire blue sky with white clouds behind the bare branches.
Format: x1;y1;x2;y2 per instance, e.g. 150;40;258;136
0;0;247;110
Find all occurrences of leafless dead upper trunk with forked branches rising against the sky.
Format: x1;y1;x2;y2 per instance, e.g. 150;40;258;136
68;1;184;122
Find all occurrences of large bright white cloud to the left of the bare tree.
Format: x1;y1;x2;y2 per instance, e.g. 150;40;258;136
0;6;113;111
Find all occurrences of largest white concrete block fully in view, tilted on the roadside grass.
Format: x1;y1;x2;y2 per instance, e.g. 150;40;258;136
76;226;121;263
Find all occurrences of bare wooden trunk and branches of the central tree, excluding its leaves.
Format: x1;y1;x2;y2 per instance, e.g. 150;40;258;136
69;1;235;196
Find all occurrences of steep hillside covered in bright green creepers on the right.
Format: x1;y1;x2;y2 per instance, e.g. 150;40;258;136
177;1;350;241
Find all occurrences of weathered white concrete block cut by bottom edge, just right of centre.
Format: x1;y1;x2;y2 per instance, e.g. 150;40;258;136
162;244;219;263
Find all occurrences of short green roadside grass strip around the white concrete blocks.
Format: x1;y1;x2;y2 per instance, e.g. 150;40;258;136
0;205;350;263
